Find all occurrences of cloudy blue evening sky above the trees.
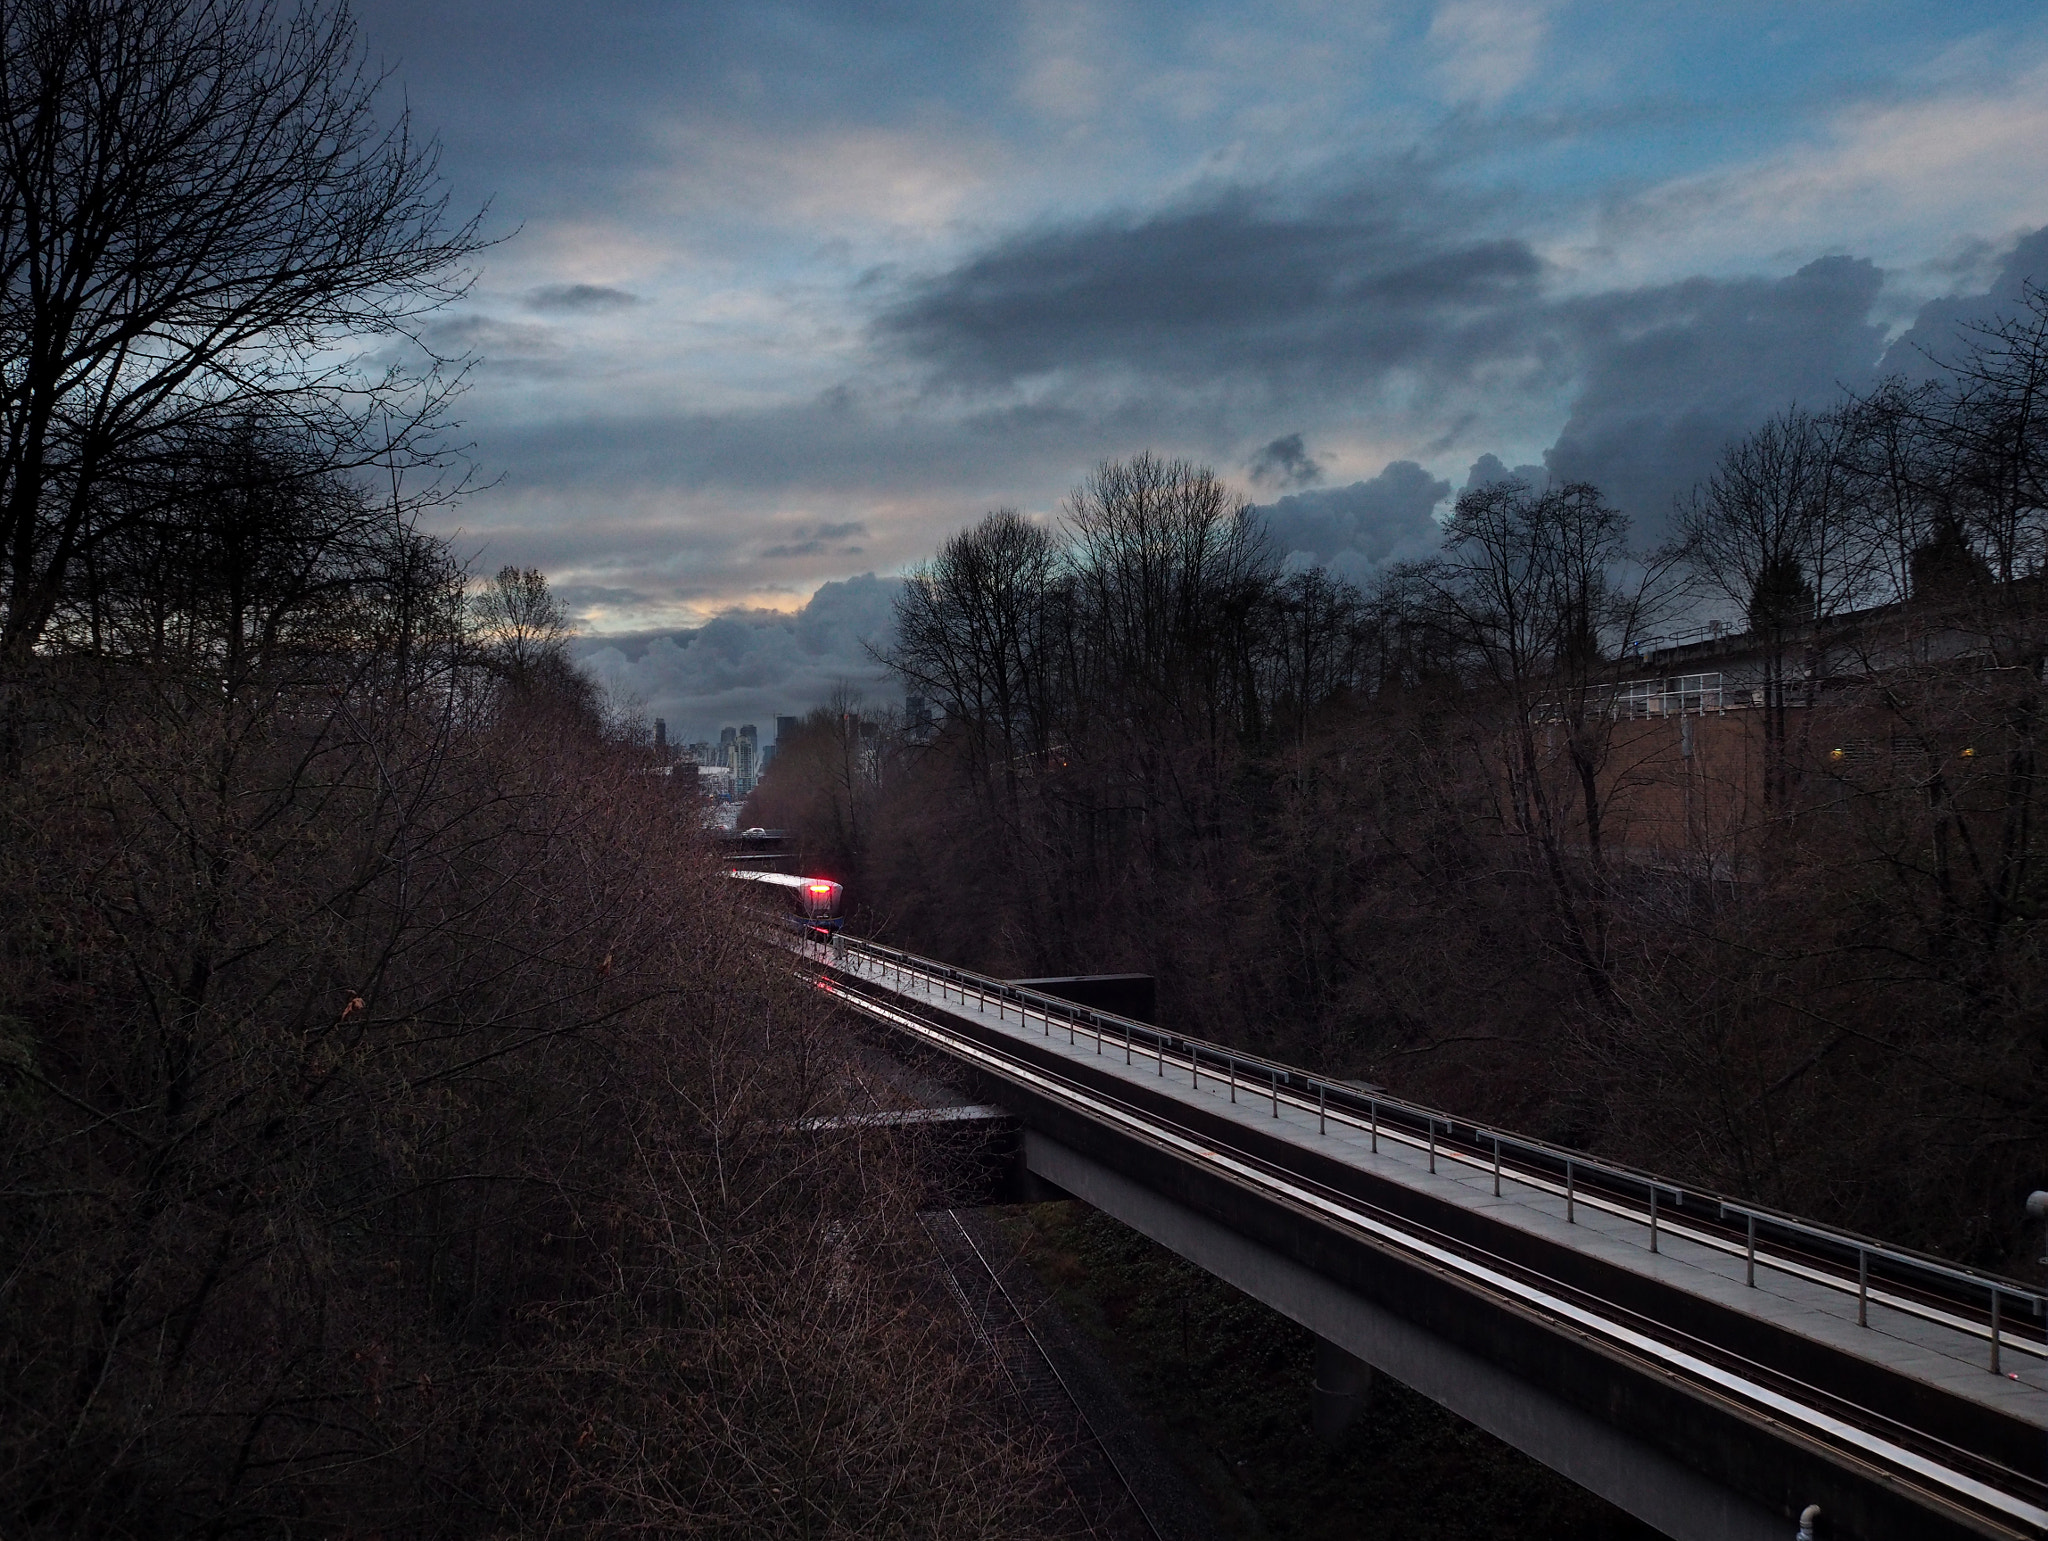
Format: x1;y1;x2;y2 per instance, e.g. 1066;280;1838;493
344;0;2048;740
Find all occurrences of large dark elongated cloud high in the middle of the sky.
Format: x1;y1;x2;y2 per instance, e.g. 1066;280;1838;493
877;179;1542;387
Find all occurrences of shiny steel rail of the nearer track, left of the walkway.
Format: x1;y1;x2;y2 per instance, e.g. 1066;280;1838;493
813;975;2048;1531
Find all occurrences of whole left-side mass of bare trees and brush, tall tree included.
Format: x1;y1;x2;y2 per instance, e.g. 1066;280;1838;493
0;0;1065;1537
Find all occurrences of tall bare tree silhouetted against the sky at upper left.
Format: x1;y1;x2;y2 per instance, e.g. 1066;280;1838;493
0;0;477;658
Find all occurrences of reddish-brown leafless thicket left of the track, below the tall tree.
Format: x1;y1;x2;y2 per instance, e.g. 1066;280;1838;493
0;525;1047;1537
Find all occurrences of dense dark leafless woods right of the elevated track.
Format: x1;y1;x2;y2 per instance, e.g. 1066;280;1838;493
748;289;2048;1271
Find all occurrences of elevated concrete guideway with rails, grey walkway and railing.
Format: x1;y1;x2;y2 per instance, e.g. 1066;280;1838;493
797;939;2048;1539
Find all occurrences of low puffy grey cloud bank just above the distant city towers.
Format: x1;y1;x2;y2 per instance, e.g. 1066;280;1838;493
578;572;899;742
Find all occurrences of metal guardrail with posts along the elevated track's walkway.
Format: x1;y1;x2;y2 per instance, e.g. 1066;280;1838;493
813;934;2048;1375
